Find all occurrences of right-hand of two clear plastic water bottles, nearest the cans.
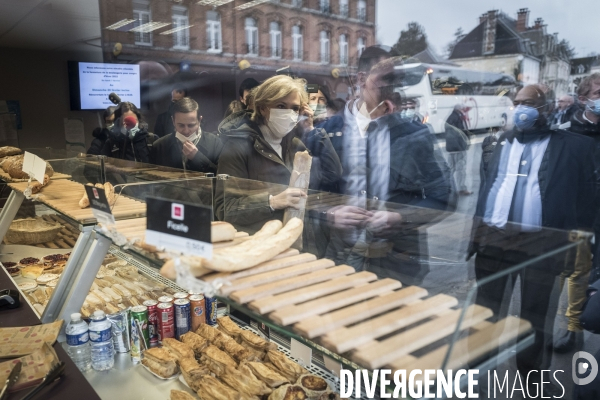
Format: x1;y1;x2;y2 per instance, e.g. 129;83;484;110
90;310;115;371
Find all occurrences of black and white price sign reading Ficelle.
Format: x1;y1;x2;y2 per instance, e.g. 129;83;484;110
146;197;212;259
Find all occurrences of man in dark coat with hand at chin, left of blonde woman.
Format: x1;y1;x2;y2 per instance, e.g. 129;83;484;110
150;97;223;173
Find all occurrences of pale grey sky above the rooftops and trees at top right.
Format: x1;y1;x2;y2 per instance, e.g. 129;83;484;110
377;0;600;57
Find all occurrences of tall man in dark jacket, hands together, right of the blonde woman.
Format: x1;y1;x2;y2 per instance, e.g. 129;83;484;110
323;58;456;284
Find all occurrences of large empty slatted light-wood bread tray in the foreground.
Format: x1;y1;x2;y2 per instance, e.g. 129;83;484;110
214;252;531;370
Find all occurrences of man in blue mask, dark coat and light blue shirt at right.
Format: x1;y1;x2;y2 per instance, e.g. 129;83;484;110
470;85;595;382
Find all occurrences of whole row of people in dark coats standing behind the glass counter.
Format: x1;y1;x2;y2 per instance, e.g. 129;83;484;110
89;48;600;396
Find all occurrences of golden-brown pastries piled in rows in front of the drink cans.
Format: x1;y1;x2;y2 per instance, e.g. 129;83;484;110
154;317;339;400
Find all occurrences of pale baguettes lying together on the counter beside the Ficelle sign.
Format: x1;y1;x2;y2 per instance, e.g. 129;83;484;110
160;218;304;279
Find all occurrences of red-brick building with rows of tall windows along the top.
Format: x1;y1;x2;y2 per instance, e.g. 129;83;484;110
99;0;376;128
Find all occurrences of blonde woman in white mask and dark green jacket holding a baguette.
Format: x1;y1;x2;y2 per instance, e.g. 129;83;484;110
215;75;341;230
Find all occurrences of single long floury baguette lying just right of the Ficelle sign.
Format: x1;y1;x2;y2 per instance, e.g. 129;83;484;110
202;218;304;272
